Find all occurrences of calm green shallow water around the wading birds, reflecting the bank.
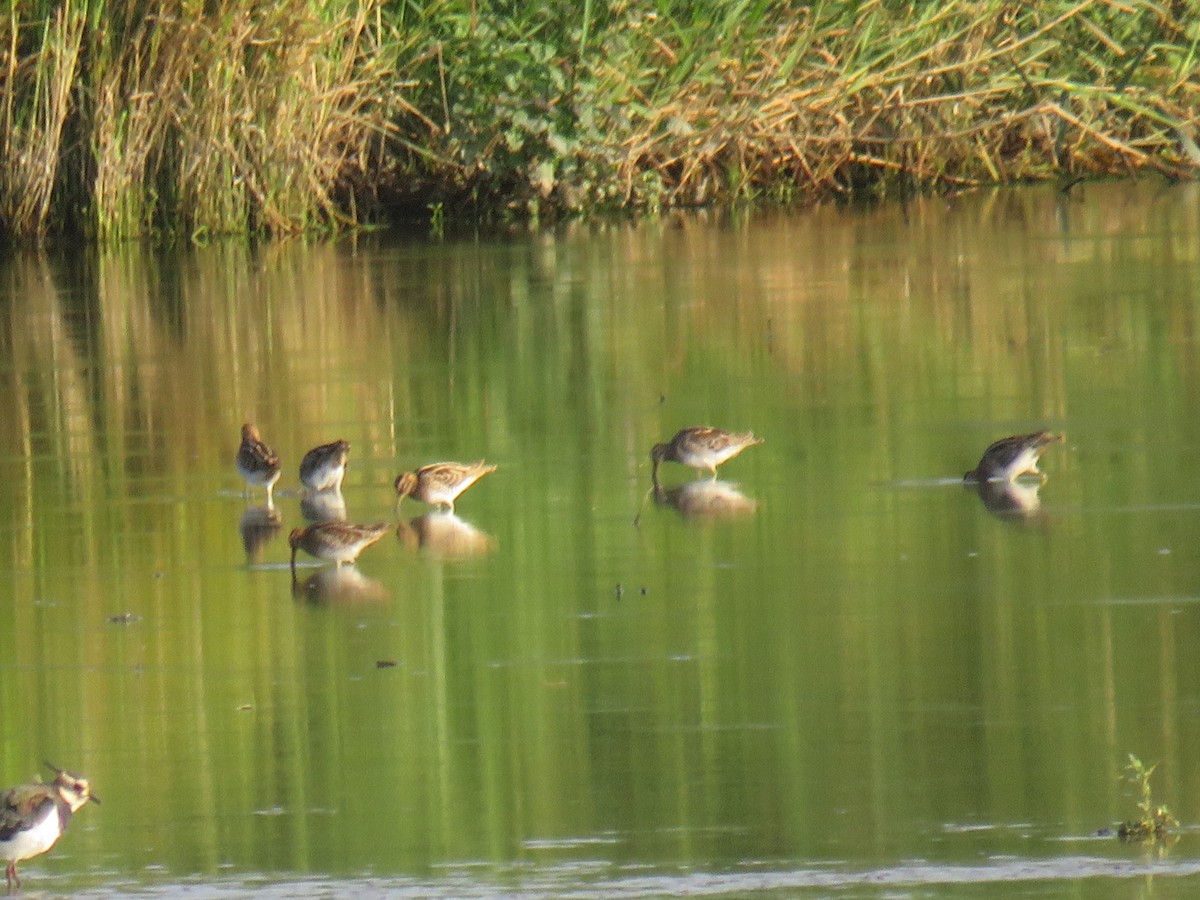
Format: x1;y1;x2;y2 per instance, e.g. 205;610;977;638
0;185;1200;898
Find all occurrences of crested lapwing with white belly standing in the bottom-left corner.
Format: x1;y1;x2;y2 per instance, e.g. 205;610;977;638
0;763;100;892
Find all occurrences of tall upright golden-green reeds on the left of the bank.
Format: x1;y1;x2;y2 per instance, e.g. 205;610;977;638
0;0;400;239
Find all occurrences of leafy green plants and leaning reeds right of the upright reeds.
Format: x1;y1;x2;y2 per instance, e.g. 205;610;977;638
403;0;1200;209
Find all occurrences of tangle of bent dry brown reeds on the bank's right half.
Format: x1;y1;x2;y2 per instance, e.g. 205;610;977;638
604;0;1198;202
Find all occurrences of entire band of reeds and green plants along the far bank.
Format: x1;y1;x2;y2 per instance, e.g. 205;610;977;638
0;0;1200;239
